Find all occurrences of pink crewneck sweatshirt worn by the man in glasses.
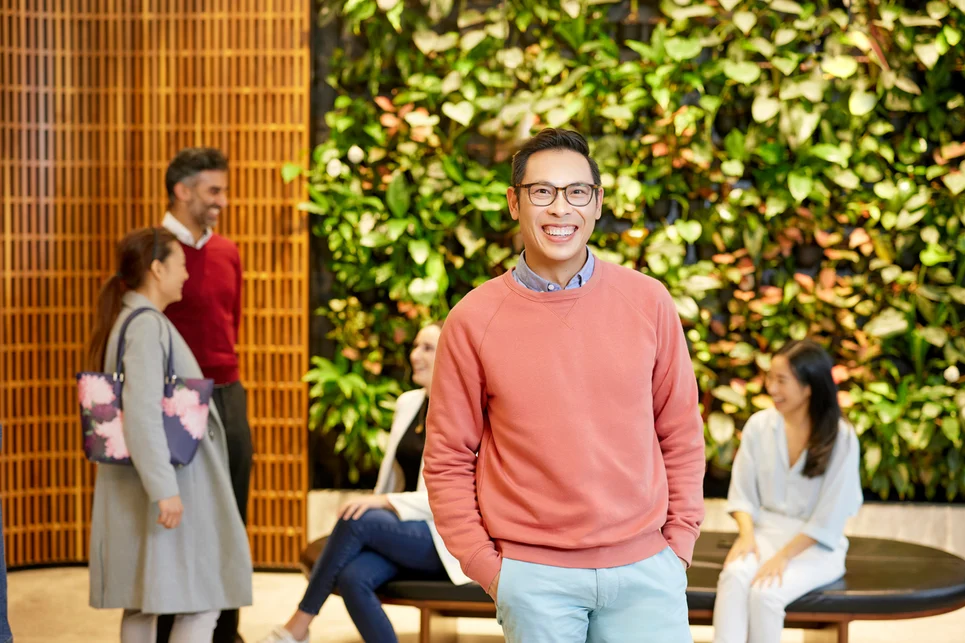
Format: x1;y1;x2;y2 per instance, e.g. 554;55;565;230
424;261;705;588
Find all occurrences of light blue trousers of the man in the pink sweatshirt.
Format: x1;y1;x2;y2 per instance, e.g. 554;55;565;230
496;547;693;643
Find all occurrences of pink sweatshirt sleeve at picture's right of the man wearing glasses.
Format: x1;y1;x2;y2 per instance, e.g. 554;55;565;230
653;286;706;566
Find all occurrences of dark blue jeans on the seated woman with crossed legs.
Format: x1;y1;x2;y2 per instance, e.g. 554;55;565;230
298;509;445;643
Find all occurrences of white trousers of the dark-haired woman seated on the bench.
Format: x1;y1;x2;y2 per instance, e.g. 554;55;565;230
714;525;846;643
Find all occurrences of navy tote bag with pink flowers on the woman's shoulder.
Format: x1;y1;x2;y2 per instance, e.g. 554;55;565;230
77;308;214;466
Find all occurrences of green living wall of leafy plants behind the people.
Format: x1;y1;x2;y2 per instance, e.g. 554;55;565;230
285;0;965;499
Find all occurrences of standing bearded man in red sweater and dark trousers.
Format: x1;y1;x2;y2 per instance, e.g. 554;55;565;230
158;148;252;643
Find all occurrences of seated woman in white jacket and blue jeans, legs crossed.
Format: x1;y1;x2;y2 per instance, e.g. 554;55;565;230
262;323;470;643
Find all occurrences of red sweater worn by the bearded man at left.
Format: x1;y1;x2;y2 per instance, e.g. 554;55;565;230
164;234;241;384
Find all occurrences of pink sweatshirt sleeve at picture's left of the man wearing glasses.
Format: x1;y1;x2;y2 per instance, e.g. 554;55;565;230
423;306;501;589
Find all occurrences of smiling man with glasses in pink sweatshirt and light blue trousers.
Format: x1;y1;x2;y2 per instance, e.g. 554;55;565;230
424;129;704;643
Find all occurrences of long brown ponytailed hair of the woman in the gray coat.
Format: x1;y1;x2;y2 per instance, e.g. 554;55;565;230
87;228;177;371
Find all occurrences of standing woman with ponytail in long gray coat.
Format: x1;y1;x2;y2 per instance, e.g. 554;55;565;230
90;228;252;643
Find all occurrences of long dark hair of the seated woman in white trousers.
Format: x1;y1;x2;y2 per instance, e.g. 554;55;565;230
777;339;841;478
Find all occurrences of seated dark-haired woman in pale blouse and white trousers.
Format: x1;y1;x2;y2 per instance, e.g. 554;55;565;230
714;340;862;643
